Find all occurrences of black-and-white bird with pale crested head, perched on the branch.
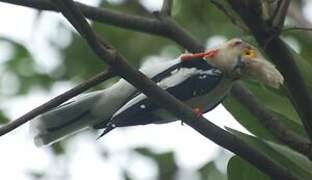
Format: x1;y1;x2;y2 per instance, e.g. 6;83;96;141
30;38;284;146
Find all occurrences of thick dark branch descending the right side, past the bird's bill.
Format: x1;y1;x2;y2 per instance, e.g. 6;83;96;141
228;0;312;139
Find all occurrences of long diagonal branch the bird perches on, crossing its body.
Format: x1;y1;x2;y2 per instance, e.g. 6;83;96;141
48;0;298;179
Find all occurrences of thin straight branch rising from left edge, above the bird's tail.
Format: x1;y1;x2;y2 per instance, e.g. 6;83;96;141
0;70;115;136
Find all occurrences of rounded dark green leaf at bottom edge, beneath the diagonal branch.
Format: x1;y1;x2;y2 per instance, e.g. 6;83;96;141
227;156;271;180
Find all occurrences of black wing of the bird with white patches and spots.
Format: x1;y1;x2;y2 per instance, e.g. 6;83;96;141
97;59;222;136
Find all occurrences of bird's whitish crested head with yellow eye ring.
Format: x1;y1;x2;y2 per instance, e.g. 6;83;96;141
205;38;284;88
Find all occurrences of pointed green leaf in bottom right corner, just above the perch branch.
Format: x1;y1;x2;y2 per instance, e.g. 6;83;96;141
227;128;312;180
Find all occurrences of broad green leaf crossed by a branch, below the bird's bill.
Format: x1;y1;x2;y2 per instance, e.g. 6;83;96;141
223;82;306;141
